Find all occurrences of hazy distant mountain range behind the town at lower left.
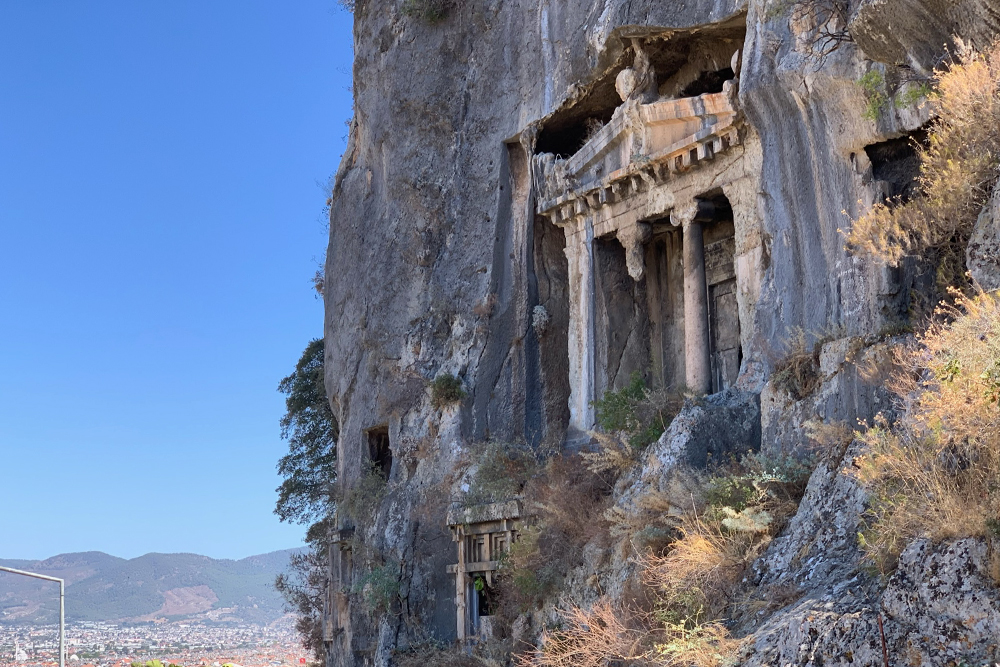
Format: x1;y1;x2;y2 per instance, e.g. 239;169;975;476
0;549;302;625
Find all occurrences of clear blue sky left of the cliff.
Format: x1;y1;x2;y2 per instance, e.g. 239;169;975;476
0;0;352;558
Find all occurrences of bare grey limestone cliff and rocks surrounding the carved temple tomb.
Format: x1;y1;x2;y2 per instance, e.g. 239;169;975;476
325;0;1000;666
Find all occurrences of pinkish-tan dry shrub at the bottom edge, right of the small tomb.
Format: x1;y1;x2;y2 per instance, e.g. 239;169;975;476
515;598;651;667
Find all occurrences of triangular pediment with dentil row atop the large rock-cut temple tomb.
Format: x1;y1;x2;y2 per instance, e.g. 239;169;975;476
534;87;740;224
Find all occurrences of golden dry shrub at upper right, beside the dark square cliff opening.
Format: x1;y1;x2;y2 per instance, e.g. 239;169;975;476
847;43;1000;285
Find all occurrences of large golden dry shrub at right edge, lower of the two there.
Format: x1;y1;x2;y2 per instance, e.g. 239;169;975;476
855;293;1000;571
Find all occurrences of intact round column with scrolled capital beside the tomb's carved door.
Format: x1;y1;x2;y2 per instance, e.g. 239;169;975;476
670;202;712;394
